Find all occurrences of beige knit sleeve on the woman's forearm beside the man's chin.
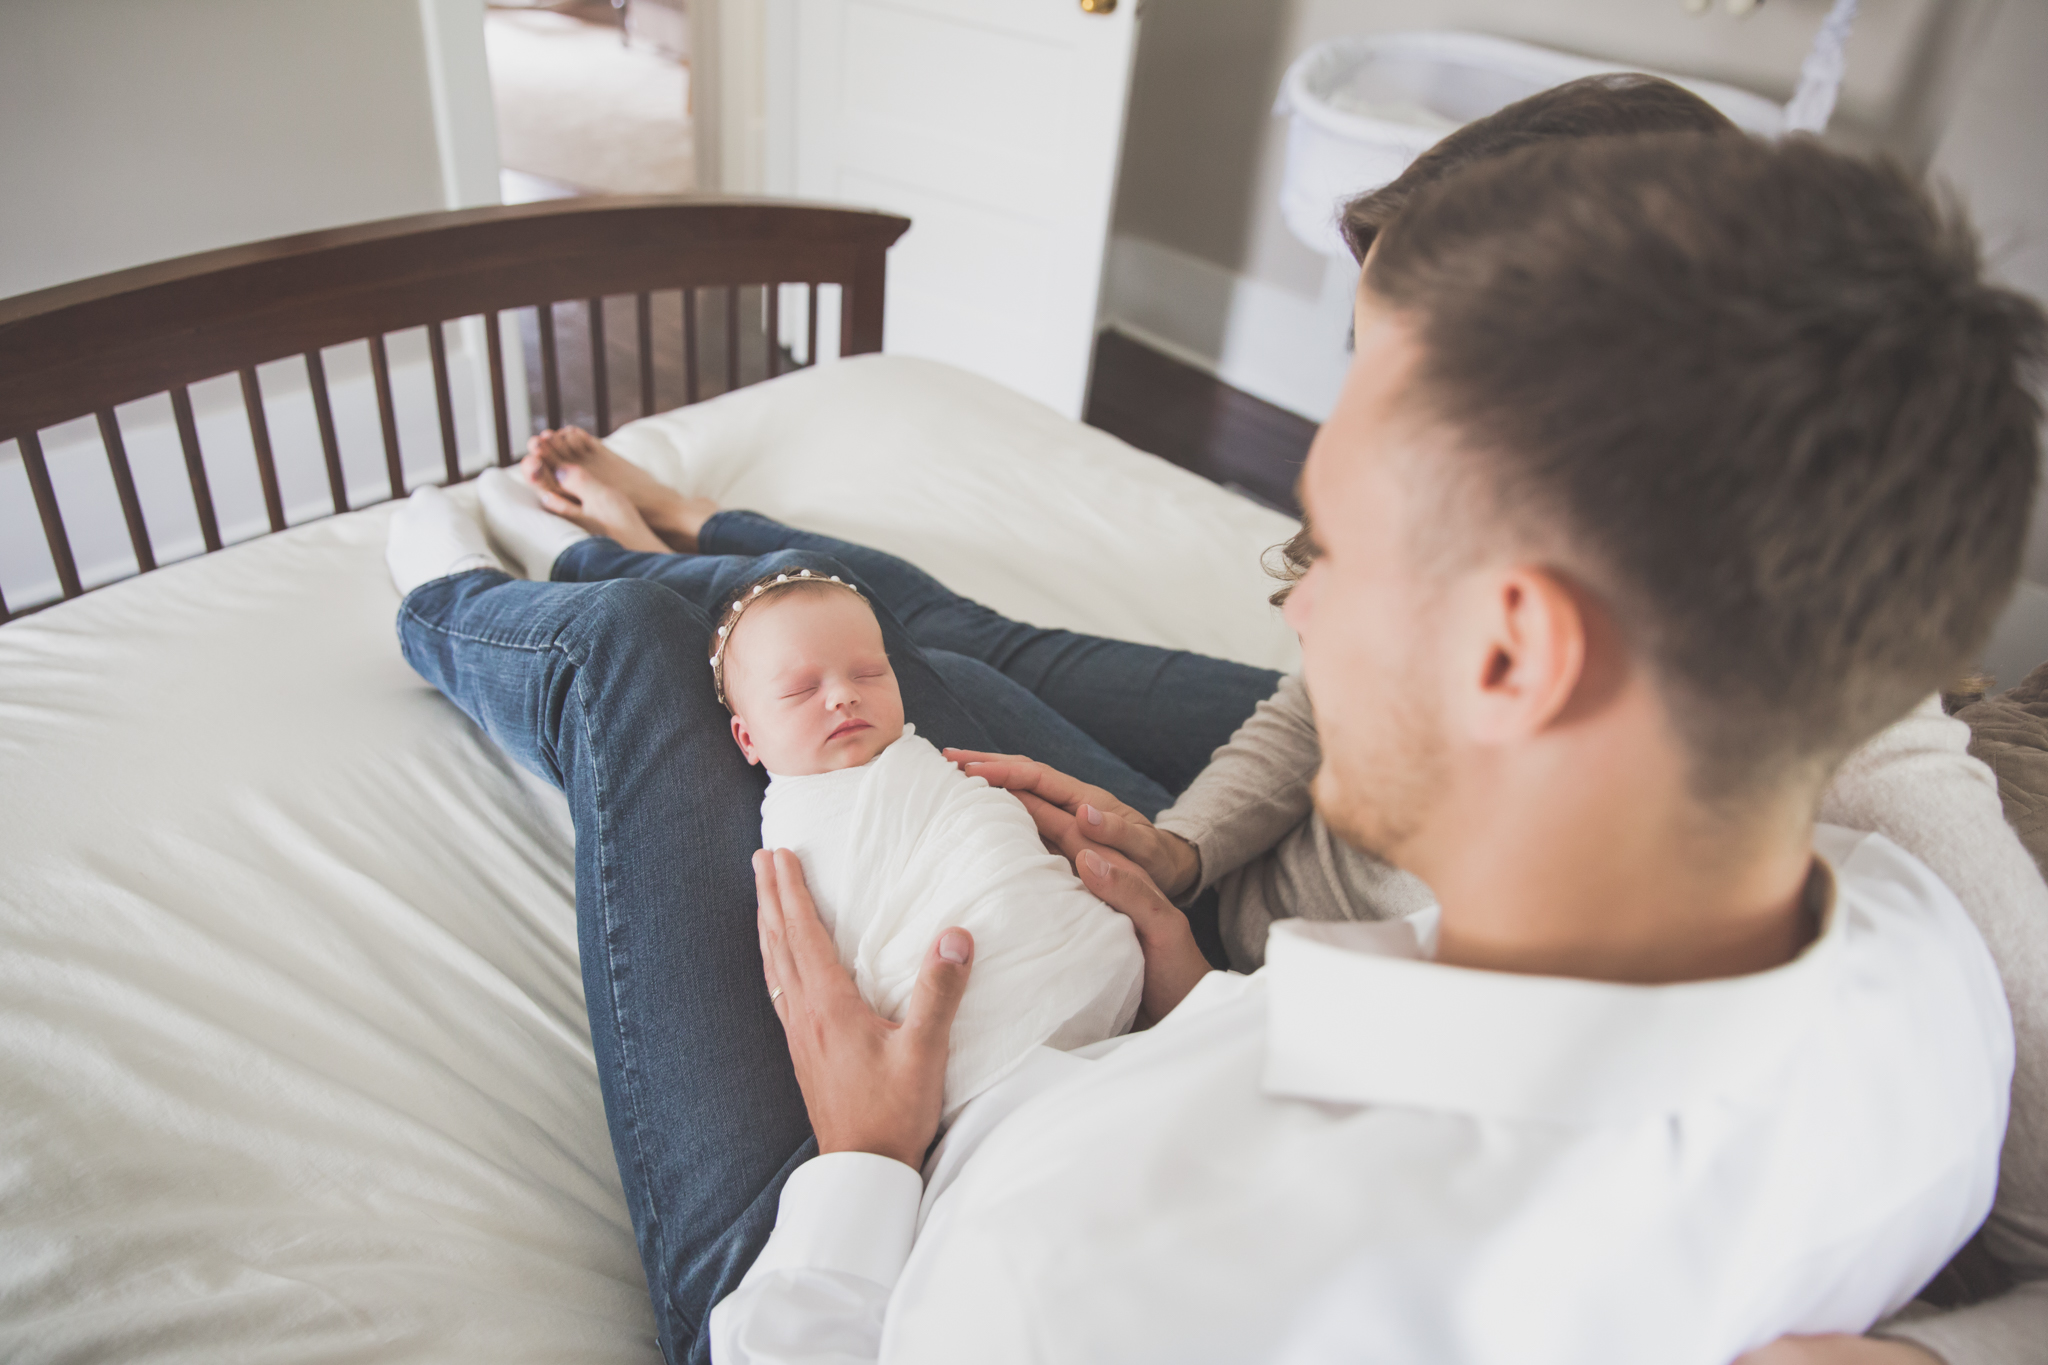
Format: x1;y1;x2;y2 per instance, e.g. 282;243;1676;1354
1153;673;1323;898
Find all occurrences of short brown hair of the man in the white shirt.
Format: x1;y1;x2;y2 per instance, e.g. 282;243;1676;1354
1366;133;2044;796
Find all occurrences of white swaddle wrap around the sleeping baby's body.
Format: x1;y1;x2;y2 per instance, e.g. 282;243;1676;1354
762;726;1145;1115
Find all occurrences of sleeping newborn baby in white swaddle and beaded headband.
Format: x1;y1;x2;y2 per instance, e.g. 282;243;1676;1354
711;571;1145;1115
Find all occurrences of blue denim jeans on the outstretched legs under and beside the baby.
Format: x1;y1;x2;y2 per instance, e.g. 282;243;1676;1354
397;512;1278;1363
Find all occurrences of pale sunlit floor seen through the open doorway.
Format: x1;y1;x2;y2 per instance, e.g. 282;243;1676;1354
483;8;696;194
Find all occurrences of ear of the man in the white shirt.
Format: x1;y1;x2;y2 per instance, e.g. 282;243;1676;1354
1470;567;1589;743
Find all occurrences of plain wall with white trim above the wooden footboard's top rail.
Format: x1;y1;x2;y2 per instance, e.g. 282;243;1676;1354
0;0;498;297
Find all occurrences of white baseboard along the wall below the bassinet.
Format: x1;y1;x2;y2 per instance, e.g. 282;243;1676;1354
1102;235;1356;422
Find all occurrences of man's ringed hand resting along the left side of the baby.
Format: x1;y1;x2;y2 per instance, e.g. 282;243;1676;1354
754;849;975;1171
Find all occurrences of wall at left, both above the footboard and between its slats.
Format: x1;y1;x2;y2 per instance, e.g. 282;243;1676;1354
0;0;507;606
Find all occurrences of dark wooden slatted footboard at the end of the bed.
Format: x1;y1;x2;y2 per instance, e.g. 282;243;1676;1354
0;196;909;622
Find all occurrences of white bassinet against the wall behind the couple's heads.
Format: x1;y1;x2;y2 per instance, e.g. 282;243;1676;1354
1276;33;1786;262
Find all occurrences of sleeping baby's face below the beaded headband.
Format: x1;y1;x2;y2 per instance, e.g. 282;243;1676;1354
725;587;903;778
